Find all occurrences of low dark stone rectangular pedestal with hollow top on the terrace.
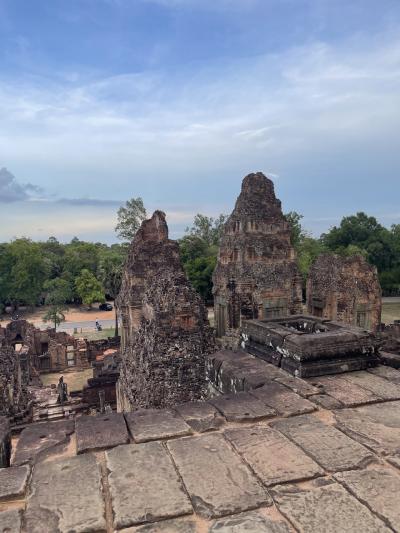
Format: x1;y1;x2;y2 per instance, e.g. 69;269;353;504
242;315;380;378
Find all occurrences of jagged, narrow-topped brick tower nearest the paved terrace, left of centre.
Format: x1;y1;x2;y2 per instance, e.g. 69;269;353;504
116;211;214;411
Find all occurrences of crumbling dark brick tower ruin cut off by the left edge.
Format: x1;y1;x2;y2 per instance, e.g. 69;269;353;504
0;346;29;416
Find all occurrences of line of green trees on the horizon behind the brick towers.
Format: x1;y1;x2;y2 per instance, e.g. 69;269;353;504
0;202;400;325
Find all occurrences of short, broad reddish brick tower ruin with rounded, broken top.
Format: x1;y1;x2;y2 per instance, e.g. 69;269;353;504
307;254;382;331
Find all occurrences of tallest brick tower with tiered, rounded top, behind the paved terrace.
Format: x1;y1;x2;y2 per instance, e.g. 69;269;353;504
213;172;302;338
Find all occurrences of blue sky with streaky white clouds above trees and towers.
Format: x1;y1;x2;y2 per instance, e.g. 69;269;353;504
0;0;400;243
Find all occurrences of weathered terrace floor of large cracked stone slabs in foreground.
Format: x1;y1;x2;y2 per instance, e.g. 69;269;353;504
0;353;400;533
